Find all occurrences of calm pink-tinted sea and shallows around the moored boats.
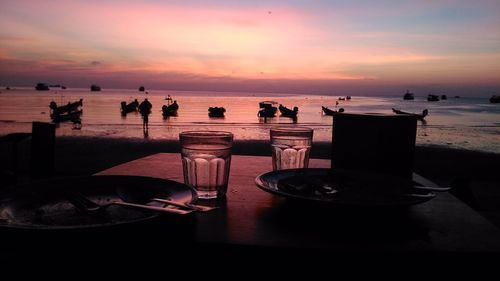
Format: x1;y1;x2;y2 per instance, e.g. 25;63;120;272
0;88;500;153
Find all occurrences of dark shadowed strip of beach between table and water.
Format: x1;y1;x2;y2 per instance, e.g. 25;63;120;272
0;137;500;227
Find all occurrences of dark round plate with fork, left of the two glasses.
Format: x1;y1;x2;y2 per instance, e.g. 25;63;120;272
0;176;196;229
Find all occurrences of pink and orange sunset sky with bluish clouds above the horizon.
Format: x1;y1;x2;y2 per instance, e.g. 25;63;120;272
0;0;500;94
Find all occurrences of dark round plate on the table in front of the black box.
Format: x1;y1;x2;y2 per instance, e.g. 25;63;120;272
255;168;435;206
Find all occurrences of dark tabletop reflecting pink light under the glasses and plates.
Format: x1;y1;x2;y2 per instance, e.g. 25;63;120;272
97;153;500;254
